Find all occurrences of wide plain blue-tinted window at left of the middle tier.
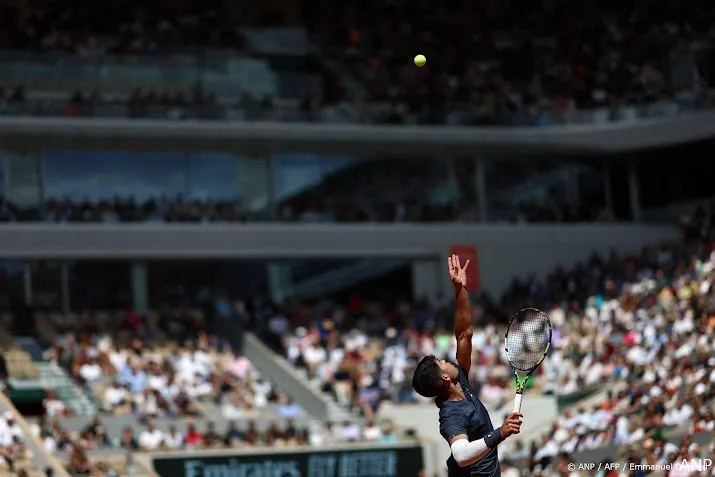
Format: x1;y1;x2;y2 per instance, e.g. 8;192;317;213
45;151;238;201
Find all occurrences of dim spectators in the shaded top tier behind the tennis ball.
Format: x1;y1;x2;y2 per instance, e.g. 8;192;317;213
0;0;713;125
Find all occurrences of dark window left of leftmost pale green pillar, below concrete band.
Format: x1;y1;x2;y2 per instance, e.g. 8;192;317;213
69;261;132;311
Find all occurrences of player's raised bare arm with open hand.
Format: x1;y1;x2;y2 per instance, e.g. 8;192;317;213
449;255;472;372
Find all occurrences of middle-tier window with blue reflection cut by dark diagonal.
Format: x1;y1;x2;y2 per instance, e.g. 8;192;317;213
273;154;462;222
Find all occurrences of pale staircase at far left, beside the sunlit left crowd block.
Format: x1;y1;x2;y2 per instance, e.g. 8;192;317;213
13;336;98;415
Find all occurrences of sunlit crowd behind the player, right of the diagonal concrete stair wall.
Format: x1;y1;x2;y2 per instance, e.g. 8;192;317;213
266;211;715;471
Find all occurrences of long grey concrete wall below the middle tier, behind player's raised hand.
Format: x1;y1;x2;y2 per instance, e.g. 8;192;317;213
0;224;679;293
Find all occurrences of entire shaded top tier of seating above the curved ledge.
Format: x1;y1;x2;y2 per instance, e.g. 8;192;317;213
0;0;712;126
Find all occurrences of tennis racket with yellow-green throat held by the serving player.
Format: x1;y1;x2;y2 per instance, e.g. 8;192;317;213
504;308;552;412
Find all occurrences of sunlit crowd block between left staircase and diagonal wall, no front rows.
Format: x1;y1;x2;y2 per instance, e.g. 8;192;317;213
36;310;279;420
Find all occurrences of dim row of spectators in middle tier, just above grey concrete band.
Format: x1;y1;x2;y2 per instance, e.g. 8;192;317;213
0;180;610;224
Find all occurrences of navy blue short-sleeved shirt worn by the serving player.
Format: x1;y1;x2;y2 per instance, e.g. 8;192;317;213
439;363;501;477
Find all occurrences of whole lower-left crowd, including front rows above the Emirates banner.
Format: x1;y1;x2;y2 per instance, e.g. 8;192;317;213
23;309;414;476
